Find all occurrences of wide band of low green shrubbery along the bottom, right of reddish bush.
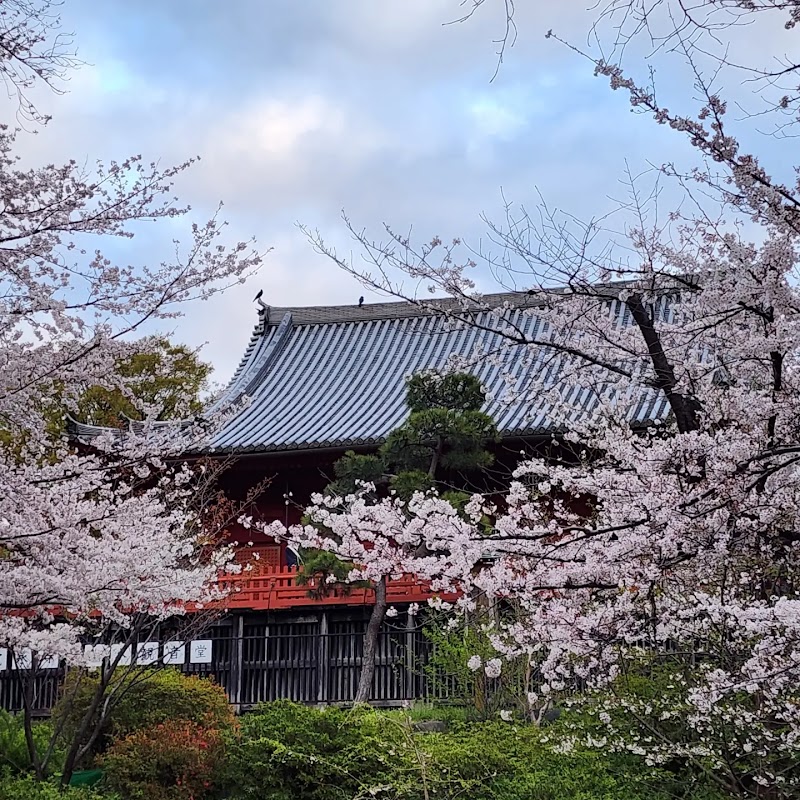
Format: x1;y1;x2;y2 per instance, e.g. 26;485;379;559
222;702;722;800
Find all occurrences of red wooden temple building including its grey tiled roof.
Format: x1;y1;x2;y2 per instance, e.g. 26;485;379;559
61;295;665;706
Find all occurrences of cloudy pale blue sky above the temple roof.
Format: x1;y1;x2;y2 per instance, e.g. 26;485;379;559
6;0;792;381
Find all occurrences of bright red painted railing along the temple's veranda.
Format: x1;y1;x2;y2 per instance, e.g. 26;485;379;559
214;567;452;611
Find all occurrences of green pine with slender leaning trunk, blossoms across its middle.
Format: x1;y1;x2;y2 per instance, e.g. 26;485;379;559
267;373;497;703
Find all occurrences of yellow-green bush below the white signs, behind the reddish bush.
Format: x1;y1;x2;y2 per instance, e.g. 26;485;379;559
53;668;234;753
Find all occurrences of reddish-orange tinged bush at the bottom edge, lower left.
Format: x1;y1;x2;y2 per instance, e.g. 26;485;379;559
101;720;225;800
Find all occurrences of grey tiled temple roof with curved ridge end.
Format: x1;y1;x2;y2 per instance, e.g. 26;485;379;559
69;294;667;453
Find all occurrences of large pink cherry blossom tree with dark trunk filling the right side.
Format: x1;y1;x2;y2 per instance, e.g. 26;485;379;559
304;0;800;798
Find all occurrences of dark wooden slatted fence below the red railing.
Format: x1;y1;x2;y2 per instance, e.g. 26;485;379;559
0;614;460;714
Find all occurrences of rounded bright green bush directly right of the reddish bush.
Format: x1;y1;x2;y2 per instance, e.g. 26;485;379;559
226;701;405;800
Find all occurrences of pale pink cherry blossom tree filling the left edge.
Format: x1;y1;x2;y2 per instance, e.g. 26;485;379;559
0;0;261;780
